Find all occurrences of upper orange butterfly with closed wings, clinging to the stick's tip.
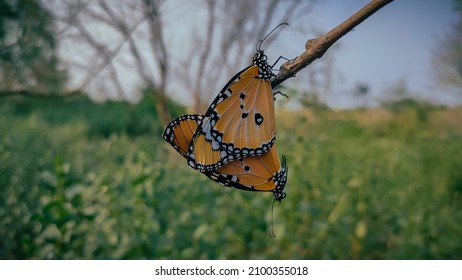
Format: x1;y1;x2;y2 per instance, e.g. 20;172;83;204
187;24;281;171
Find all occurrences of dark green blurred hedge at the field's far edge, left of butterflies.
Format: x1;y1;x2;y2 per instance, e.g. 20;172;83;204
2;94;185;137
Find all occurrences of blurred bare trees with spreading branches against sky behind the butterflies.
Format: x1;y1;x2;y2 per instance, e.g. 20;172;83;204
49;0;314;123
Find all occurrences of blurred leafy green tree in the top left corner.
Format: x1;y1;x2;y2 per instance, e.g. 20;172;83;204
0;0;66;95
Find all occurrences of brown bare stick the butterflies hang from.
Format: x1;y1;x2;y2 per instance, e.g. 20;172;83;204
271;0;393;88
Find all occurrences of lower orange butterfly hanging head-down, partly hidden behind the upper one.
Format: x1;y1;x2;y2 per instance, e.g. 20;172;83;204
162;114;288;201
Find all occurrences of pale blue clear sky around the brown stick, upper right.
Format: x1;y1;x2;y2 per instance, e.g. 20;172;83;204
282;0;461;107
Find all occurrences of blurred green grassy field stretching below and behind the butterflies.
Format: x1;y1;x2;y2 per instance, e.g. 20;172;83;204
0;97;462;259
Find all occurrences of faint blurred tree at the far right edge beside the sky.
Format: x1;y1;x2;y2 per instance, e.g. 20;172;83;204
434;0;462;93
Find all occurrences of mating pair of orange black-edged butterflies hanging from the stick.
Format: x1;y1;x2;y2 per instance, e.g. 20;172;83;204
162;24;288;201
